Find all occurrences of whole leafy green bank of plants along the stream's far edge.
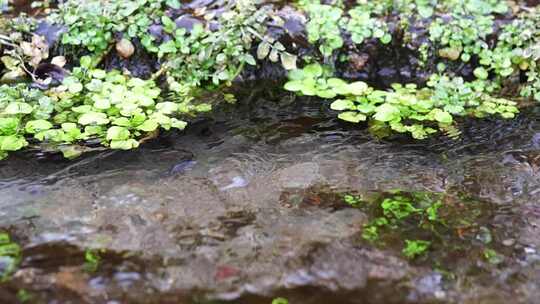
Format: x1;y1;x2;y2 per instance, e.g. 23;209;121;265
0;0;540;158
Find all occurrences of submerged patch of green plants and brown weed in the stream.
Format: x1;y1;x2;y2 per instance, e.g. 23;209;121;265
343;190;501;265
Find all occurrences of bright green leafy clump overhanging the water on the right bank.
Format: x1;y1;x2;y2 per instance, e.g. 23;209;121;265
285;64;518;139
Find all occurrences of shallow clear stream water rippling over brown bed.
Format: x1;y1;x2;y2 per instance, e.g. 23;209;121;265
0;83;540;304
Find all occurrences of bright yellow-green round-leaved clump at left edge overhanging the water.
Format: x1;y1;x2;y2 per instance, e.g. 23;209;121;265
0;57;200;157
